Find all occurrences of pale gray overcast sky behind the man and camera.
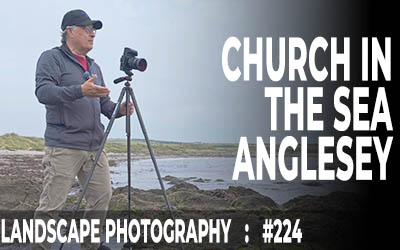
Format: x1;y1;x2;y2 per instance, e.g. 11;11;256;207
0;0;356;143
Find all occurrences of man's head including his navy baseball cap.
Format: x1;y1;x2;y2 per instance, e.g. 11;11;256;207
61;10;103;54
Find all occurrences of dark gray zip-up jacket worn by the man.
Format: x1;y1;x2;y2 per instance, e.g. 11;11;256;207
35;44;121;151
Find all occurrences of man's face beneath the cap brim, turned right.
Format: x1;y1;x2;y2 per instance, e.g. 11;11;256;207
69;25;96;53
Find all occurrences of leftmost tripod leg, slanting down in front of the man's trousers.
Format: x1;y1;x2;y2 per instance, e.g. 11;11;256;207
59;88;127;250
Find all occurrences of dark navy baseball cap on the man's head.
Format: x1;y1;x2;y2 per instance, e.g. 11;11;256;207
61;10;103;30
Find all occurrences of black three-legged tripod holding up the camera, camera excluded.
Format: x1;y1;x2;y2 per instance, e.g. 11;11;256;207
59;71;183;250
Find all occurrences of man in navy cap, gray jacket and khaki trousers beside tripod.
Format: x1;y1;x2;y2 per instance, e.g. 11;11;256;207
32;10;133;249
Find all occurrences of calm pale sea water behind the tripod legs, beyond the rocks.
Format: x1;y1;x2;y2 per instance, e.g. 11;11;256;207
110;157;363;204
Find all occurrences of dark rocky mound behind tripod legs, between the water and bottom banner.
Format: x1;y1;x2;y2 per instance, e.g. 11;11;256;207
110;181;277;211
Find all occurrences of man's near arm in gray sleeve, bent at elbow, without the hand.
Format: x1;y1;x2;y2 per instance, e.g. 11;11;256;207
35;51;83;105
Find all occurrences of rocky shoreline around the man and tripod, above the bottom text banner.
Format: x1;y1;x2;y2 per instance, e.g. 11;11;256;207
0;149;366;210
